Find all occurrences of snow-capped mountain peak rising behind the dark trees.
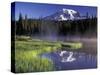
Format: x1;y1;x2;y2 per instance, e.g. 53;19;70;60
44;8;85;21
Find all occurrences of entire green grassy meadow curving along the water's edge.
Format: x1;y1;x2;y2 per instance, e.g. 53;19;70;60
15;36;82;73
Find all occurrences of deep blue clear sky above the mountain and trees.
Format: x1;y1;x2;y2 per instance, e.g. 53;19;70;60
12;2;97;20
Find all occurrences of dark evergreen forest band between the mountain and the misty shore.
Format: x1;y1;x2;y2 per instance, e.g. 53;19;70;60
12;14;97;37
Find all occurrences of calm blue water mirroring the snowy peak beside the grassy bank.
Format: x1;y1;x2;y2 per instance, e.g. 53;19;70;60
42;51;97;70
